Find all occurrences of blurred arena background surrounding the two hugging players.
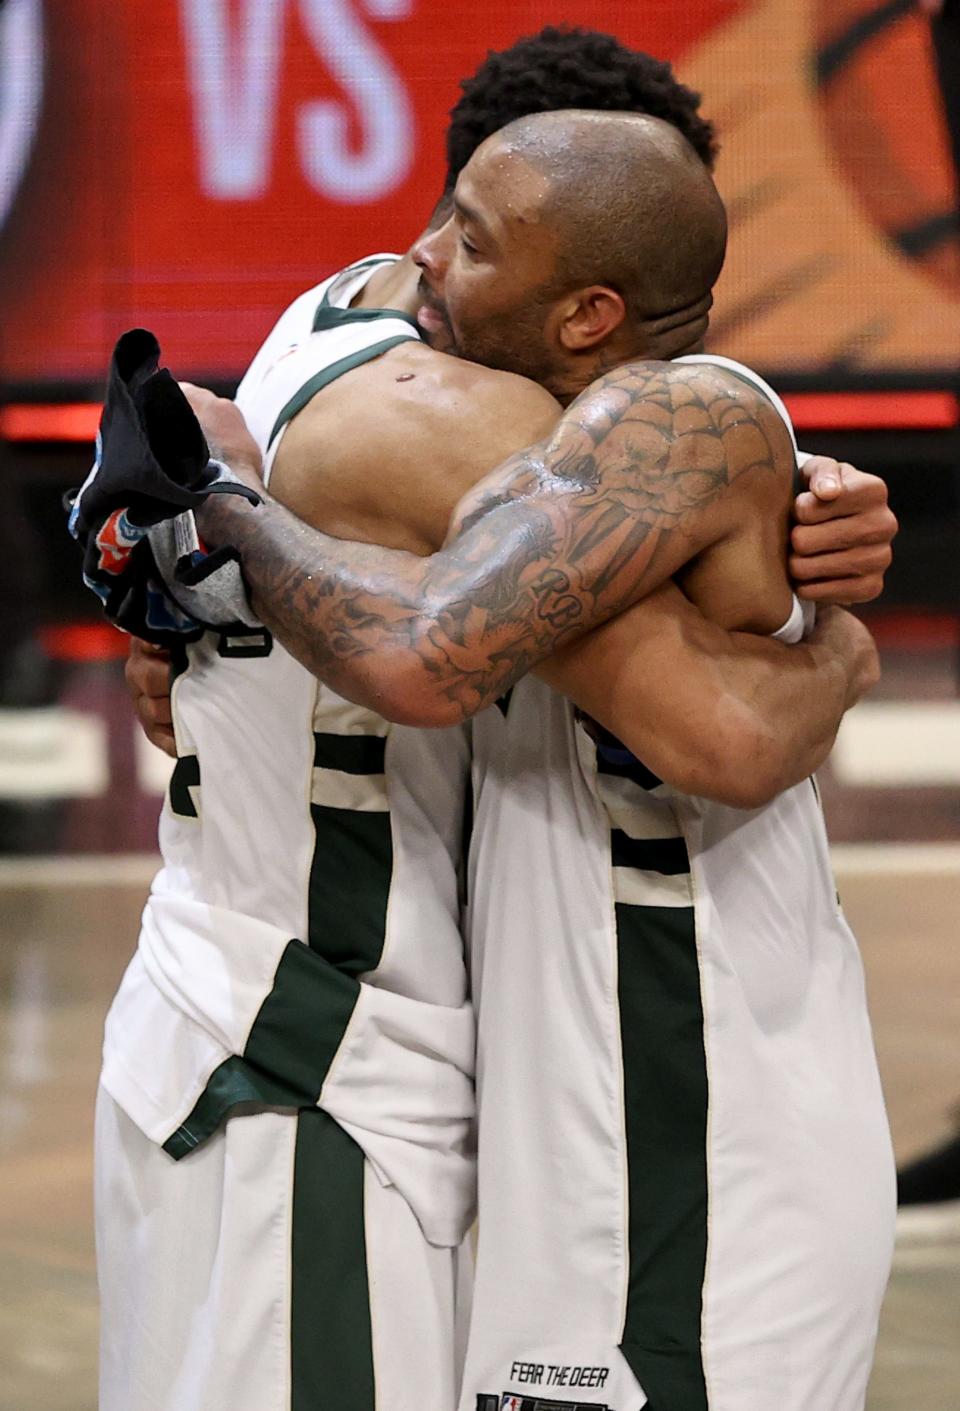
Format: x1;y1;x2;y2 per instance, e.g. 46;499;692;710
0;0;960;1411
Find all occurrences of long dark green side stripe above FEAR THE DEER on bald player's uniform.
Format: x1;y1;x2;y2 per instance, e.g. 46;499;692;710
616;904;707;1411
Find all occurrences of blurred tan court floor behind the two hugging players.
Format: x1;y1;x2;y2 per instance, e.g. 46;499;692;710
0;642;960;1411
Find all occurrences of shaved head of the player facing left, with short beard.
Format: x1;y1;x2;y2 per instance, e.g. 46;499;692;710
414;109;727;401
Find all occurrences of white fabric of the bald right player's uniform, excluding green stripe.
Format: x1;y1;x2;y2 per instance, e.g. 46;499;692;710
460;680;894;1411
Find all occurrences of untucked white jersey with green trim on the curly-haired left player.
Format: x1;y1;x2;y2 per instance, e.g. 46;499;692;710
104;257;474;1245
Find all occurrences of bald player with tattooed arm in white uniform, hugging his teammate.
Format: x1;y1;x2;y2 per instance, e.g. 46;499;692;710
168;114;892;1411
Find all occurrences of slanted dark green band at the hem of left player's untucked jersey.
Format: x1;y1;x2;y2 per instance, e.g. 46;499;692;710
164;941;359;1160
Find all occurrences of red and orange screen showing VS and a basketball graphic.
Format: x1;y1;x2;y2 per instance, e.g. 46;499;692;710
0;0;960;388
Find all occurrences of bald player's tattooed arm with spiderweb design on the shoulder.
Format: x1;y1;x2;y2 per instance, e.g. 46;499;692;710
200;364;792;725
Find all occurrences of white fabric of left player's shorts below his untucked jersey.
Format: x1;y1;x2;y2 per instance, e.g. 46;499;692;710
96;1089;470;1411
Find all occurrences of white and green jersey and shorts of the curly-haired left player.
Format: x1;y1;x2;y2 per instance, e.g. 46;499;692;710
99;257;474;1411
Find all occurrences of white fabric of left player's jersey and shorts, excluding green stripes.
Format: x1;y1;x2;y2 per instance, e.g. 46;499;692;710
97;256;476;1411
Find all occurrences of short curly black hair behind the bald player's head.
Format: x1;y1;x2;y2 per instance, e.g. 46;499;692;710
445;24;719;192
